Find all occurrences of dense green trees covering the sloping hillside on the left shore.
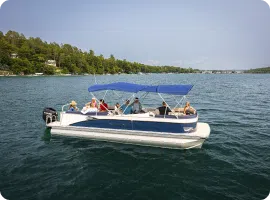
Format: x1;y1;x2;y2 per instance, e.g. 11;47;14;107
0;31;196;75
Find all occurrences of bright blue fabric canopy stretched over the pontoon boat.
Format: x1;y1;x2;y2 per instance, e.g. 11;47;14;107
88;82;193;95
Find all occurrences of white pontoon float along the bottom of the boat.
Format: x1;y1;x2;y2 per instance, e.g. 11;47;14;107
47;122;210;149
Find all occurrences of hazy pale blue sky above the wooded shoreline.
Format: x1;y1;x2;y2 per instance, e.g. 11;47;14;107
0;0;270;70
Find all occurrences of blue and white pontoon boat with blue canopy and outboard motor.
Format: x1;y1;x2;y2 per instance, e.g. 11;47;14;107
43;82;210;149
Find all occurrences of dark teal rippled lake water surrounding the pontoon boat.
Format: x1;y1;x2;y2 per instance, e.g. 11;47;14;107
0;74;270;200
